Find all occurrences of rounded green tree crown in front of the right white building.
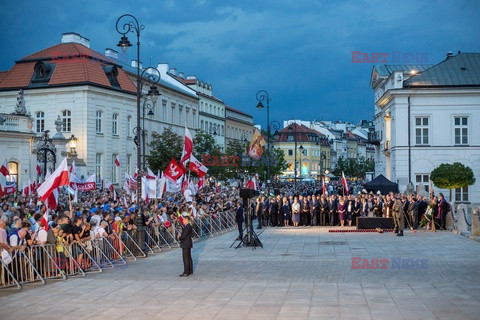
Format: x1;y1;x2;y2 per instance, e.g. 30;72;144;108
430;162;475;189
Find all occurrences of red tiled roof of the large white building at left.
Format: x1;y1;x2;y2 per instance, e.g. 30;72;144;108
0;43;137;93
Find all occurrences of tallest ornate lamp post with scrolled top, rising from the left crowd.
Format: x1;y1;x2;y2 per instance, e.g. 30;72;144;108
115;14;160;252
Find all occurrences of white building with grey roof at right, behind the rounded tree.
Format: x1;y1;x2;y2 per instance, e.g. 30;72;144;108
370;52;480;203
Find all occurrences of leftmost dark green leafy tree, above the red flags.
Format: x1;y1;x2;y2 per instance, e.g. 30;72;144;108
147;127;183;172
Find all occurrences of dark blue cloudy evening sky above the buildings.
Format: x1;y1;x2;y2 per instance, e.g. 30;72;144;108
0;0;480;126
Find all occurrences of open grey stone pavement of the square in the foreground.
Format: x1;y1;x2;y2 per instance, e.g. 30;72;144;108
0;228;480;320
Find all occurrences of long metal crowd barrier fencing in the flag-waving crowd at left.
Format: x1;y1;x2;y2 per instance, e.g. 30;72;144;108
0;211;236;289
